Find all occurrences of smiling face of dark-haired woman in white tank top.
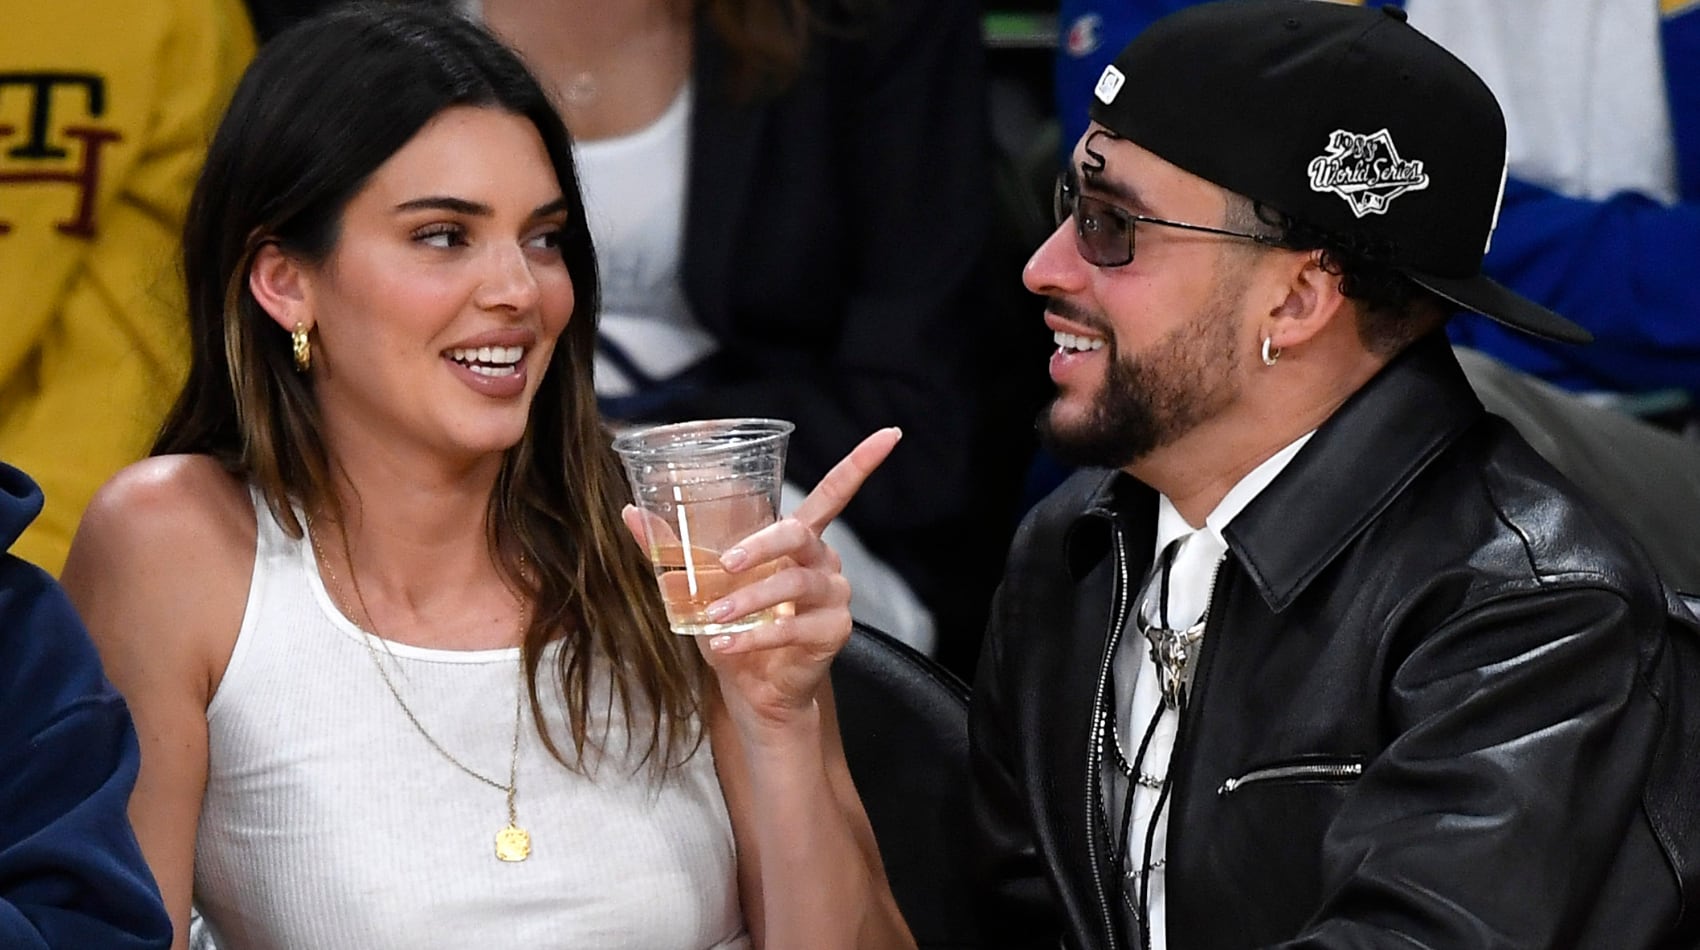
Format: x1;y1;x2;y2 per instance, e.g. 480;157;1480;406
303;107;573;464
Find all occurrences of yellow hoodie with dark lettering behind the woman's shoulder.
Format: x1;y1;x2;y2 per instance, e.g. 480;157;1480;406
0;0;253;573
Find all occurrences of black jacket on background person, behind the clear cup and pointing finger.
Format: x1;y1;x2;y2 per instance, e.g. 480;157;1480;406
658;0;986;556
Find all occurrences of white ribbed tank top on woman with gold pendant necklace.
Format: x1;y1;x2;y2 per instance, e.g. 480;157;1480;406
194;498;750;950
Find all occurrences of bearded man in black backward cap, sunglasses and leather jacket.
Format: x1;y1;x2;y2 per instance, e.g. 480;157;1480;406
971;0;1700;950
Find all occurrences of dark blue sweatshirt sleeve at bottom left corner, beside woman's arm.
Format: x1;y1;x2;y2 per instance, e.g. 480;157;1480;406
0;464;172;950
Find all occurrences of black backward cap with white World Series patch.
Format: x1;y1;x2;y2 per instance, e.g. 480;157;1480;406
1090;0;1593;343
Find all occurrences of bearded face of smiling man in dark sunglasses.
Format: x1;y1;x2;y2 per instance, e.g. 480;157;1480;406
1023;126;1256;467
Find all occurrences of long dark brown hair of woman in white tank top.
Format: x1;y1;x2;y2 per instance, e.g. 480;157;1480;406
164;5;706;772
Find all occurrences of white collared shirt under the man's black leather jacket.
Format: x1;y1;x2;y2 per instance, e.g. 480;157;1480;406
1105;430;1316;950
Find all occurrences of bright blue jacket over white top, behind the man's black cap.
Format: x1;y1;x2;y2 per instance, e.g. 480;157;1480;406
1056;0;1700;401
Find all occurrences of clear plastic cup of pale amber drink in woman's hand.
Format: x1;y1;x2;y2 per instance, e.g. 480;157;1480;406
614;418;792;636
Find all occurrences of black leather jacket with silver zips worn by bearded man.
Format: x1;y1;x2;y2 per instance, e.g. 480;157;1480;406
971;335;1700;950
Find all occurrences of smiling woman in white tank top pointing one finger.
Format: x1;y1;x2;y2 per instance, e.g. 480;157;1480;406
65;7;911;950
